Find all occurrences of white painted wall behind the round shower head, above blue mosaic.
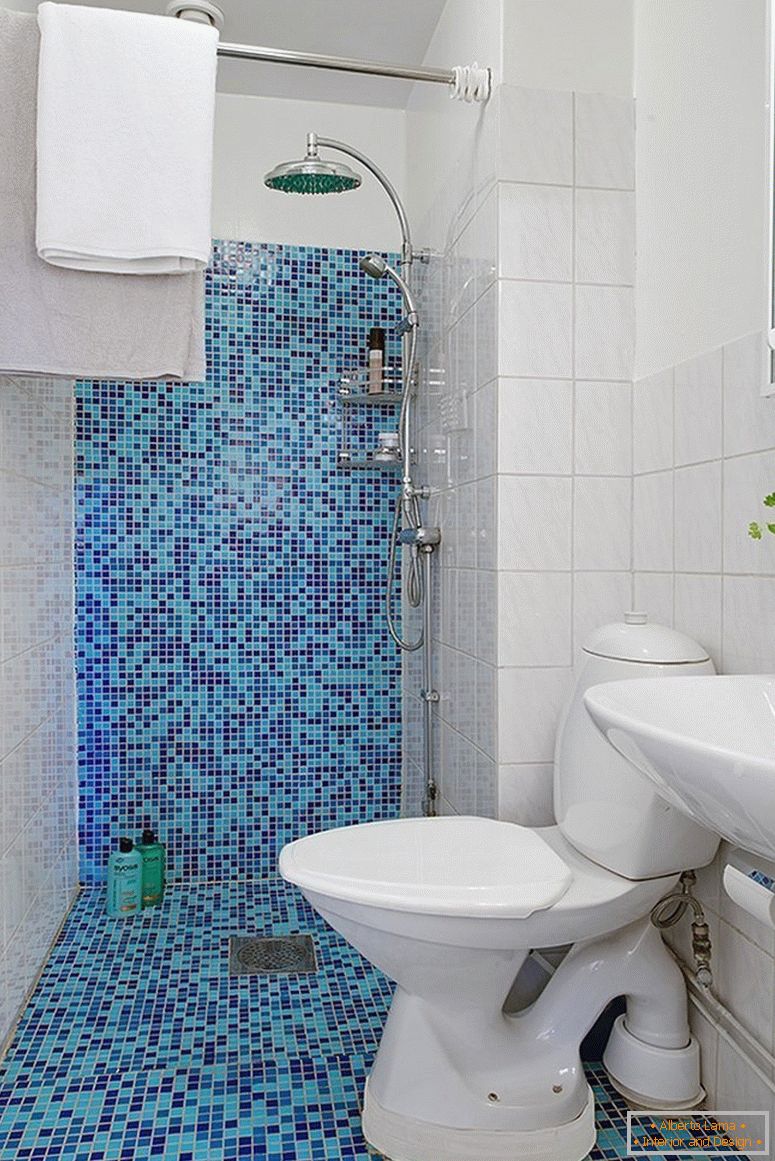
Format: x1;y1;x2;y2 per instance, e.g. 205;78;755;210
212;93;406;250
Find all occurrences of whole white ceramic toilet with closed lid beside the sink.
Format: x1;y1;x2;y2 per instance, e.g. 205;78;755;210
280;614;718;1161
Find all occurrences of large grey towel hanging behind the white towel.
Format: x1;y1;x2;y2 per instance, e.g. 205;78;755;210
0;8;204;381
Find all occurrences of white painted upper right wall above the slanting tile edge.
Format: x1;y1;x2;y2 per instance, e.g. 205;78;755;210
635;0;767;377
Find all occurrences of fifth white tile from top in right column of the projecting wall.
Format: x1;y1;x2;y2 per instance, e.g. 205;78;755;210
573;476;632;572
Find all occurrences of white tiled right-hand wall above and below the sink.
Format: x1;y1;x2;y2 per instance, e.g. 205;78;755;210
632;334;775;1111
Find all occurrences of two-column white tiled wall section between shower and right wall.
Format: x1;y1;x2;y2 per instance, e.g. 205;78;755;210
497;86;635;825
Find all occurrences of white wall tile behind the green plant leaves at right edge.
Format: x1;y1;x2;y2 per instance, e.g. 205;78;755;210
724;452;775;575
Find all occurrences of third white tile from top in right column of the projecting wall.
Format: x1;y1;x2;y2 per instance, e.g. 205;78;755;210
575;286;635;380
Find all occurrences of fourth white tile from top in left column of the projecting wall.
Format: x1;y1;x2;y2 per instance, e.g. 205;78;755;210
498;377;573;476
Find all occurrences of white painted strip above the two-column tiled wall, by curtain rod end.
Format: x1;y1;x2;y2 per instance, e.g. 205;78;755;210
504;0;631;96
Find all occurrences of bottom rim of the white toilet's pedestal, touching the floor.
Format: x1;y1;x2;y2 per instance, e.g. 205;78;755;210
363;1081;596;1161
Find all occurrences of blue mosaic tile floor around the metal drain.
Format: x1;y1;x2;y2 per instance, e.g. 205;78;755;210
0;880;739;1161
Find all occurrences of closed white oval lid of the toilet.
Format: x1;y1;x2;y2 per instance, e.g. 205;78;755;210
280;816;572;918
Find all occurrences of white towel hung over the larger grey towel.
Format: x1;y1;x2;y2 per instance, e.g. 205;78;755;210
36;0;218;274
